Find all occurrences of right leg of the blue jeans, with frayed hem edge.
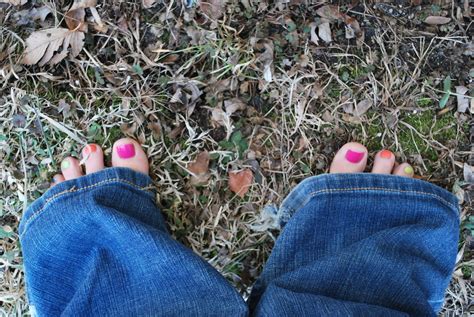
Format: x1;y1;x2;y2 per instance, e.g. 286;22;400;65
249;174;459;316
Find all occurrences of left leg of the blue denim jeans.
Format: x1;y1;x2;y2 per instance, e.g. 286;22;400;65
20;168;248;316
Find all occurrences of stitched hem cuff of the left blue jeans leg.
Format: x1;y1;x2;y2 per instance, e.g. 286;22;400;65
19;167;155;236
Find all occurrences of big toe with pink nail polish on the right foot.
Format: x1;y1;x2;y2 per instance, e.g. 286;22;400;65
329;142;367;173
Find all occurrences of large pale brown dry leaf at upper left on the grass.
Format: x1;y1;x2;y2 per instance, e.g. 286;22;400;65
22;28;84;66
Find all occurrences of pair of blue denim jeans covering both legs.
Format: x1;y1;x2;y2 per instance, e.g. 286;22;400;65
20;168;459;316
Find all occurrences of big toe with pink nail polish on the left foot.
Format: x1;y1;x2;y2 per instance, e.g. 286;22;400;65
112;138;148;175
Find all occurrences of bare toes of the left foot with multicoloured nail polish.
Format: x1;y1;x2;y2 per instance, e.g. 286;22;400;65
53;138;149;185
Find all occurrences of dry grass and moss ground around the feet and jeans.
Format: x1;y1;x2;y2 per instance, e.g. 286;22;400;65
0;1;474;316
